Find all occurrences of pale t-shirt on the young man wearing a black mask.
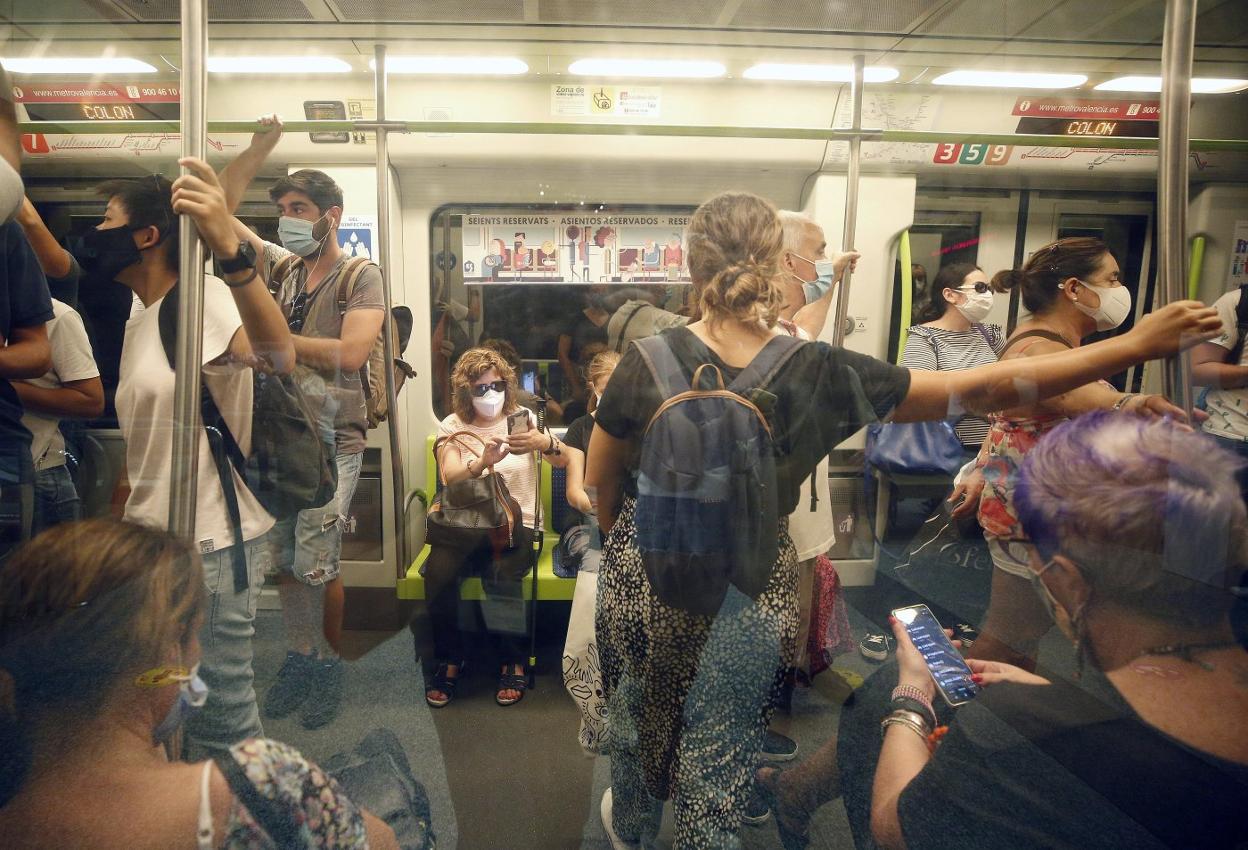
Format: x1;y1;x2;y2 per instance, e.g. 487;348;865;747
117;277;273;553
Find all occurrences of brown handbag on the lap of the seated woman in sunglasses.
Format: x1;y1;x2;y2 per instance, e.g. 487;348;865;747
424;431;524;552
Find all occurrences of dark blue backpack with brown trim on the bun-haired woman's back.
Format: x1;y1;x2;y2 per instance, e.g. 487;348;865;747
633;335;806;615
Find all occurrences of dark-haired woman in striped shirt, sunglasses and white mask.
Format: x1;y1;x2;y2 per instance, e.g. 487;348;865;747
901;263;1005;453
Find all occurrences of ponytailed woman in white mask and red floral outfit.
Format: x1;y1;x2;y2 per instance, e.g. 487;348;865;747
953;236;1184;670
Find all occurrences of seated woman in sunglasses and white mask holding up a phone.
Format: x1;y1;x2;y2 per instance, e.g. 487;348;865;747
424;348;568;708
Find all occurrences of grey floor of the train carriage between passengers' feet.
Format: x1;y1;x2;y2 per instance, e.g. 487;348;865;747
255;496;1073;850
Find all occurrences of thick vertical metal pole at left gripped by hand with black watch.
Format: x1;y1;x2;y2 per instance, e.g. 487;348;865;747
168;0;207;543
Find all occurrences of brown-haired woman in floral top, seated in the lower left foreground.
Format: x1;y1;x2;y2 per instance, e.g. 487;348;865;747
0;519;398;850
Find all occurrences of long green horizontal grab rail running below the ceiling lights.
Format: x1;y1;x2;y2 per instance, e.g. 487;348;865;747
20;120;1248;151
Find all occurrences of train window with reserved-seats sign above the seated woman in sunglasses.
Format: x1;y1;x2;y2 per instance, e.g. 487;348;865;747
429;205;693;424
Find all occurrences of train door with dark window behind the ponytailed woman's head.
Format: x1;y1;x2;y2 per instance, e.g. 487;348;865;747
1026;192;1154;392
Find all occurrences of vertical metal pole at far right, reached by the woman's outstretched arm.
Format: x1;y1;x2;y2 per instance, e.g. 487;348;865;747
1157;0;1197;413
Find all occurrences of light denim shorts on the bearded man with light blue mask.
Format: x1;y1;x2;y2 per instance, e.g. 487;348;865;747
270;452;364;585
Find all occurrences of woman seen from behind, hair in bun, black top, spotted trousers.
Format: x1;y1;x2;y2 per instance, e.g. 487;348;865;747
585;192;1221;849
